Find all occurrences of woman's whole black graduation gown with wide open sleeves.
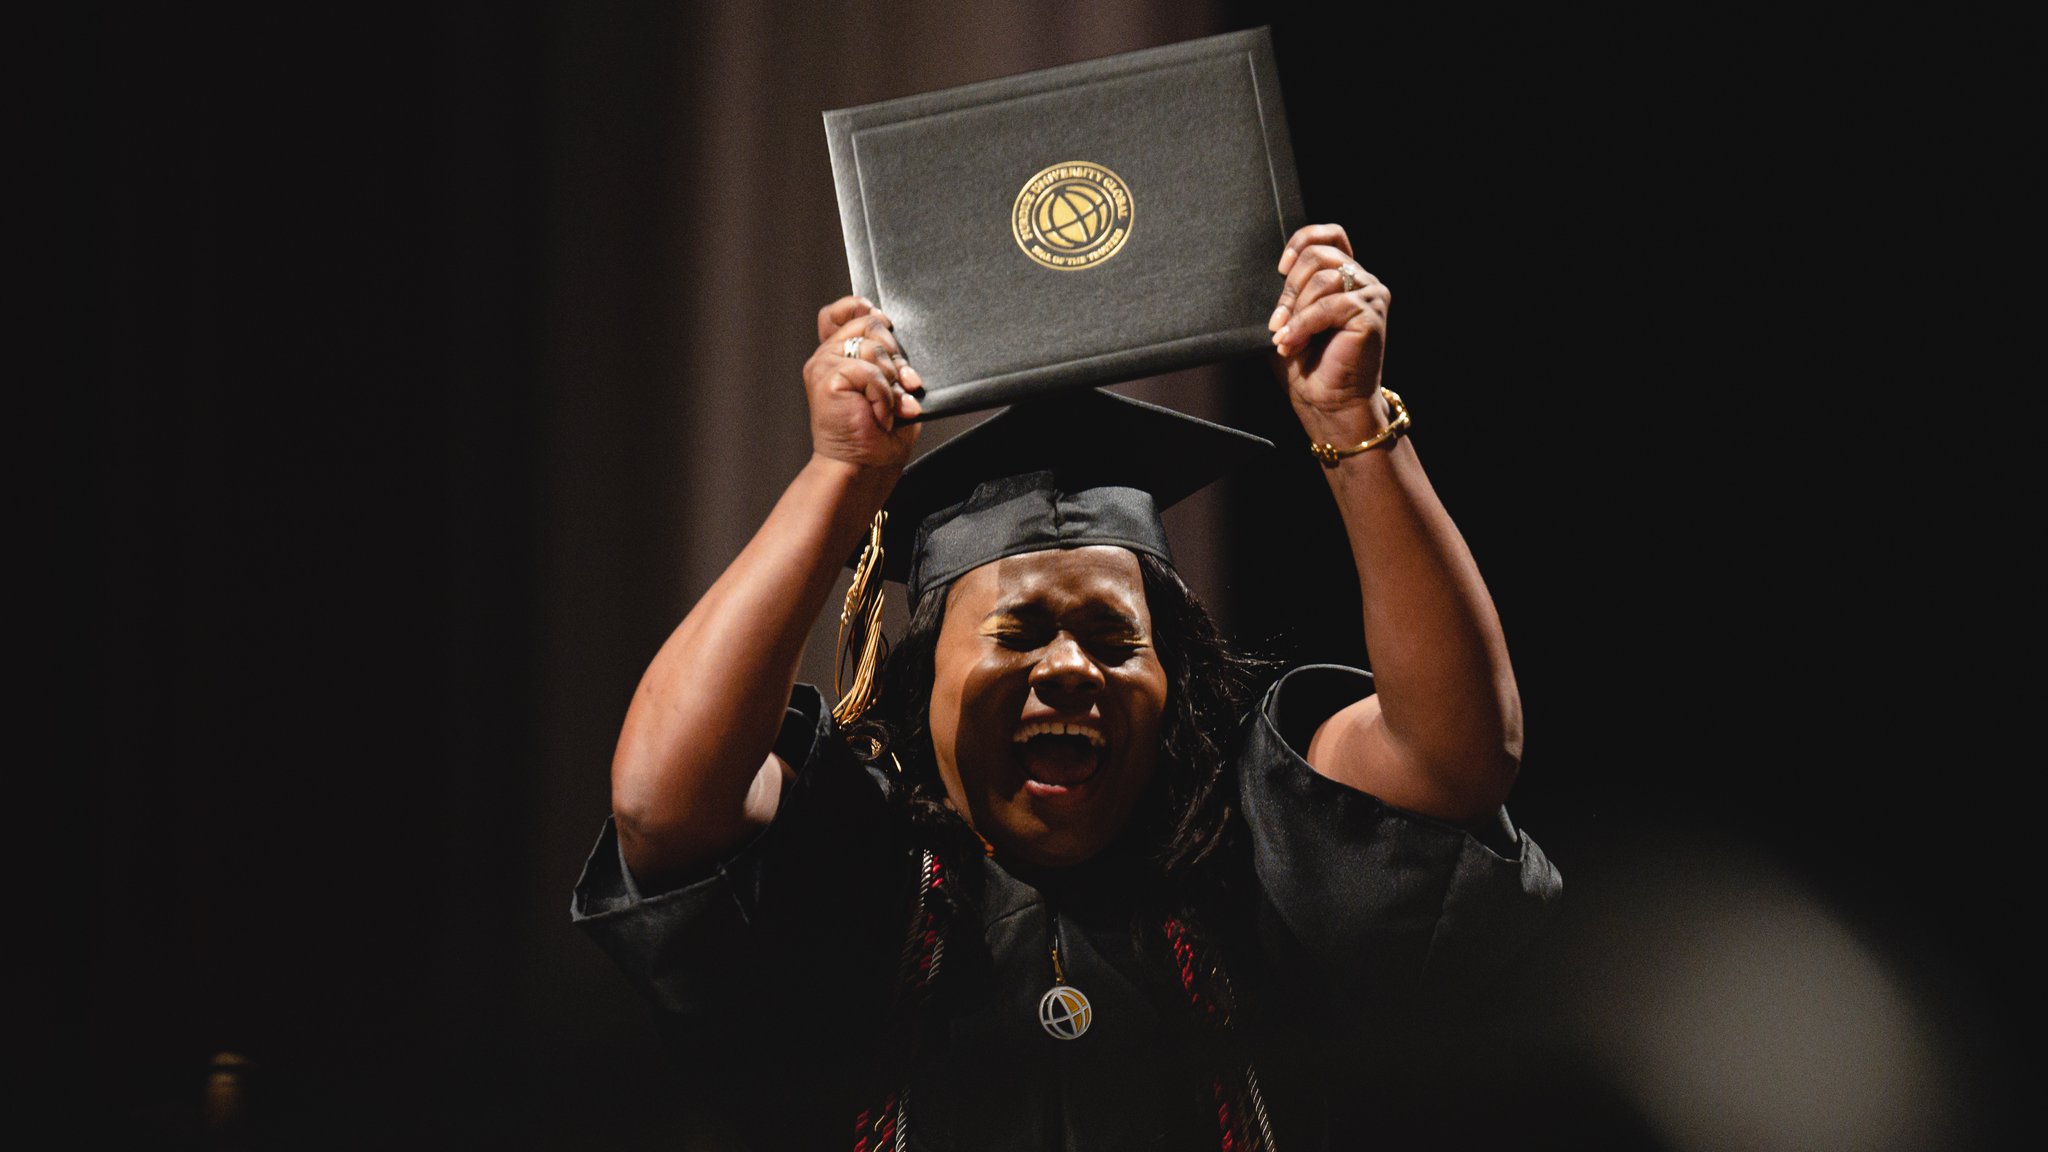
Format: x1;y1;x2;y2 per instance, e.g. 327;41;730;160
571;666;1561;1152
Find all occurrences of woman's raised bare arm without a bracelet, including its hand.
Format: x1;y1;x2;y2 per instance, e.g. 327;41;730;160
612;297;924;886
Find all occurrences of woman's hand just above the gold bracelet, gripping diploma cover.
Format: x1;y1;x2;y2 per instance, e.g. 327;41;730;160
1266;223;1393;439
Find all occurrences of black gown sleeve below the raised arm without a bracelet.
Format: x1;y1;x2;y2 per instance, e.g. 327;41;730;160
569;685;901;1025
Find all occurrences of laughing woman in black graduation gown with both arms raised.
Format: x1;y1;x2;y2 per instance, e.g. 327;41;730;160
575;225;1556;1148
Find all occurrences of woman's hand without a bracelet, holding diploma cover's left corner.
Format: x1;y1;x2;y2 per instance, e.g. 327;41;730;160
803;295;924;471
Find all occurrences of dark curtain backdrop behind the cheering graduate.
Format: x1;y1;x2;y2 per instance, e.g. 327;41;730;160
88;0;2038;1152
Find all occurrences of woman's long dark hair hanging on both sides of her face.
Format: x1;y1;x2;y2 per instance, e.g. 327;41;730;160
872;553;1272;902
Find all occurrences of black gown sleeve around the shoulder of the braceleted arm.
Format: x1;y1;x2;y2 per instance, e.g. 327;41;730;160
1237;664;1561;1019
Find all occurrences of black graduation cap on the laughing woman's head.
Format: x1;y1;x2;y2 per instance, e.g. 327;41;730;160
883;387;1274;603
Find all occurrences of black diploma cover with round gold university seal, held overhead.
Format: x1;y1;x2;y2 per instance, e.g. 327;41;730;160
825;29;1303;416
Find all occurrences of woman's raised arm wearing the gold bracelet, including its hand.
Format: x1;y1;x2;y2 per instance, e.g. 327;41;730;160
1268;223;1522;824
